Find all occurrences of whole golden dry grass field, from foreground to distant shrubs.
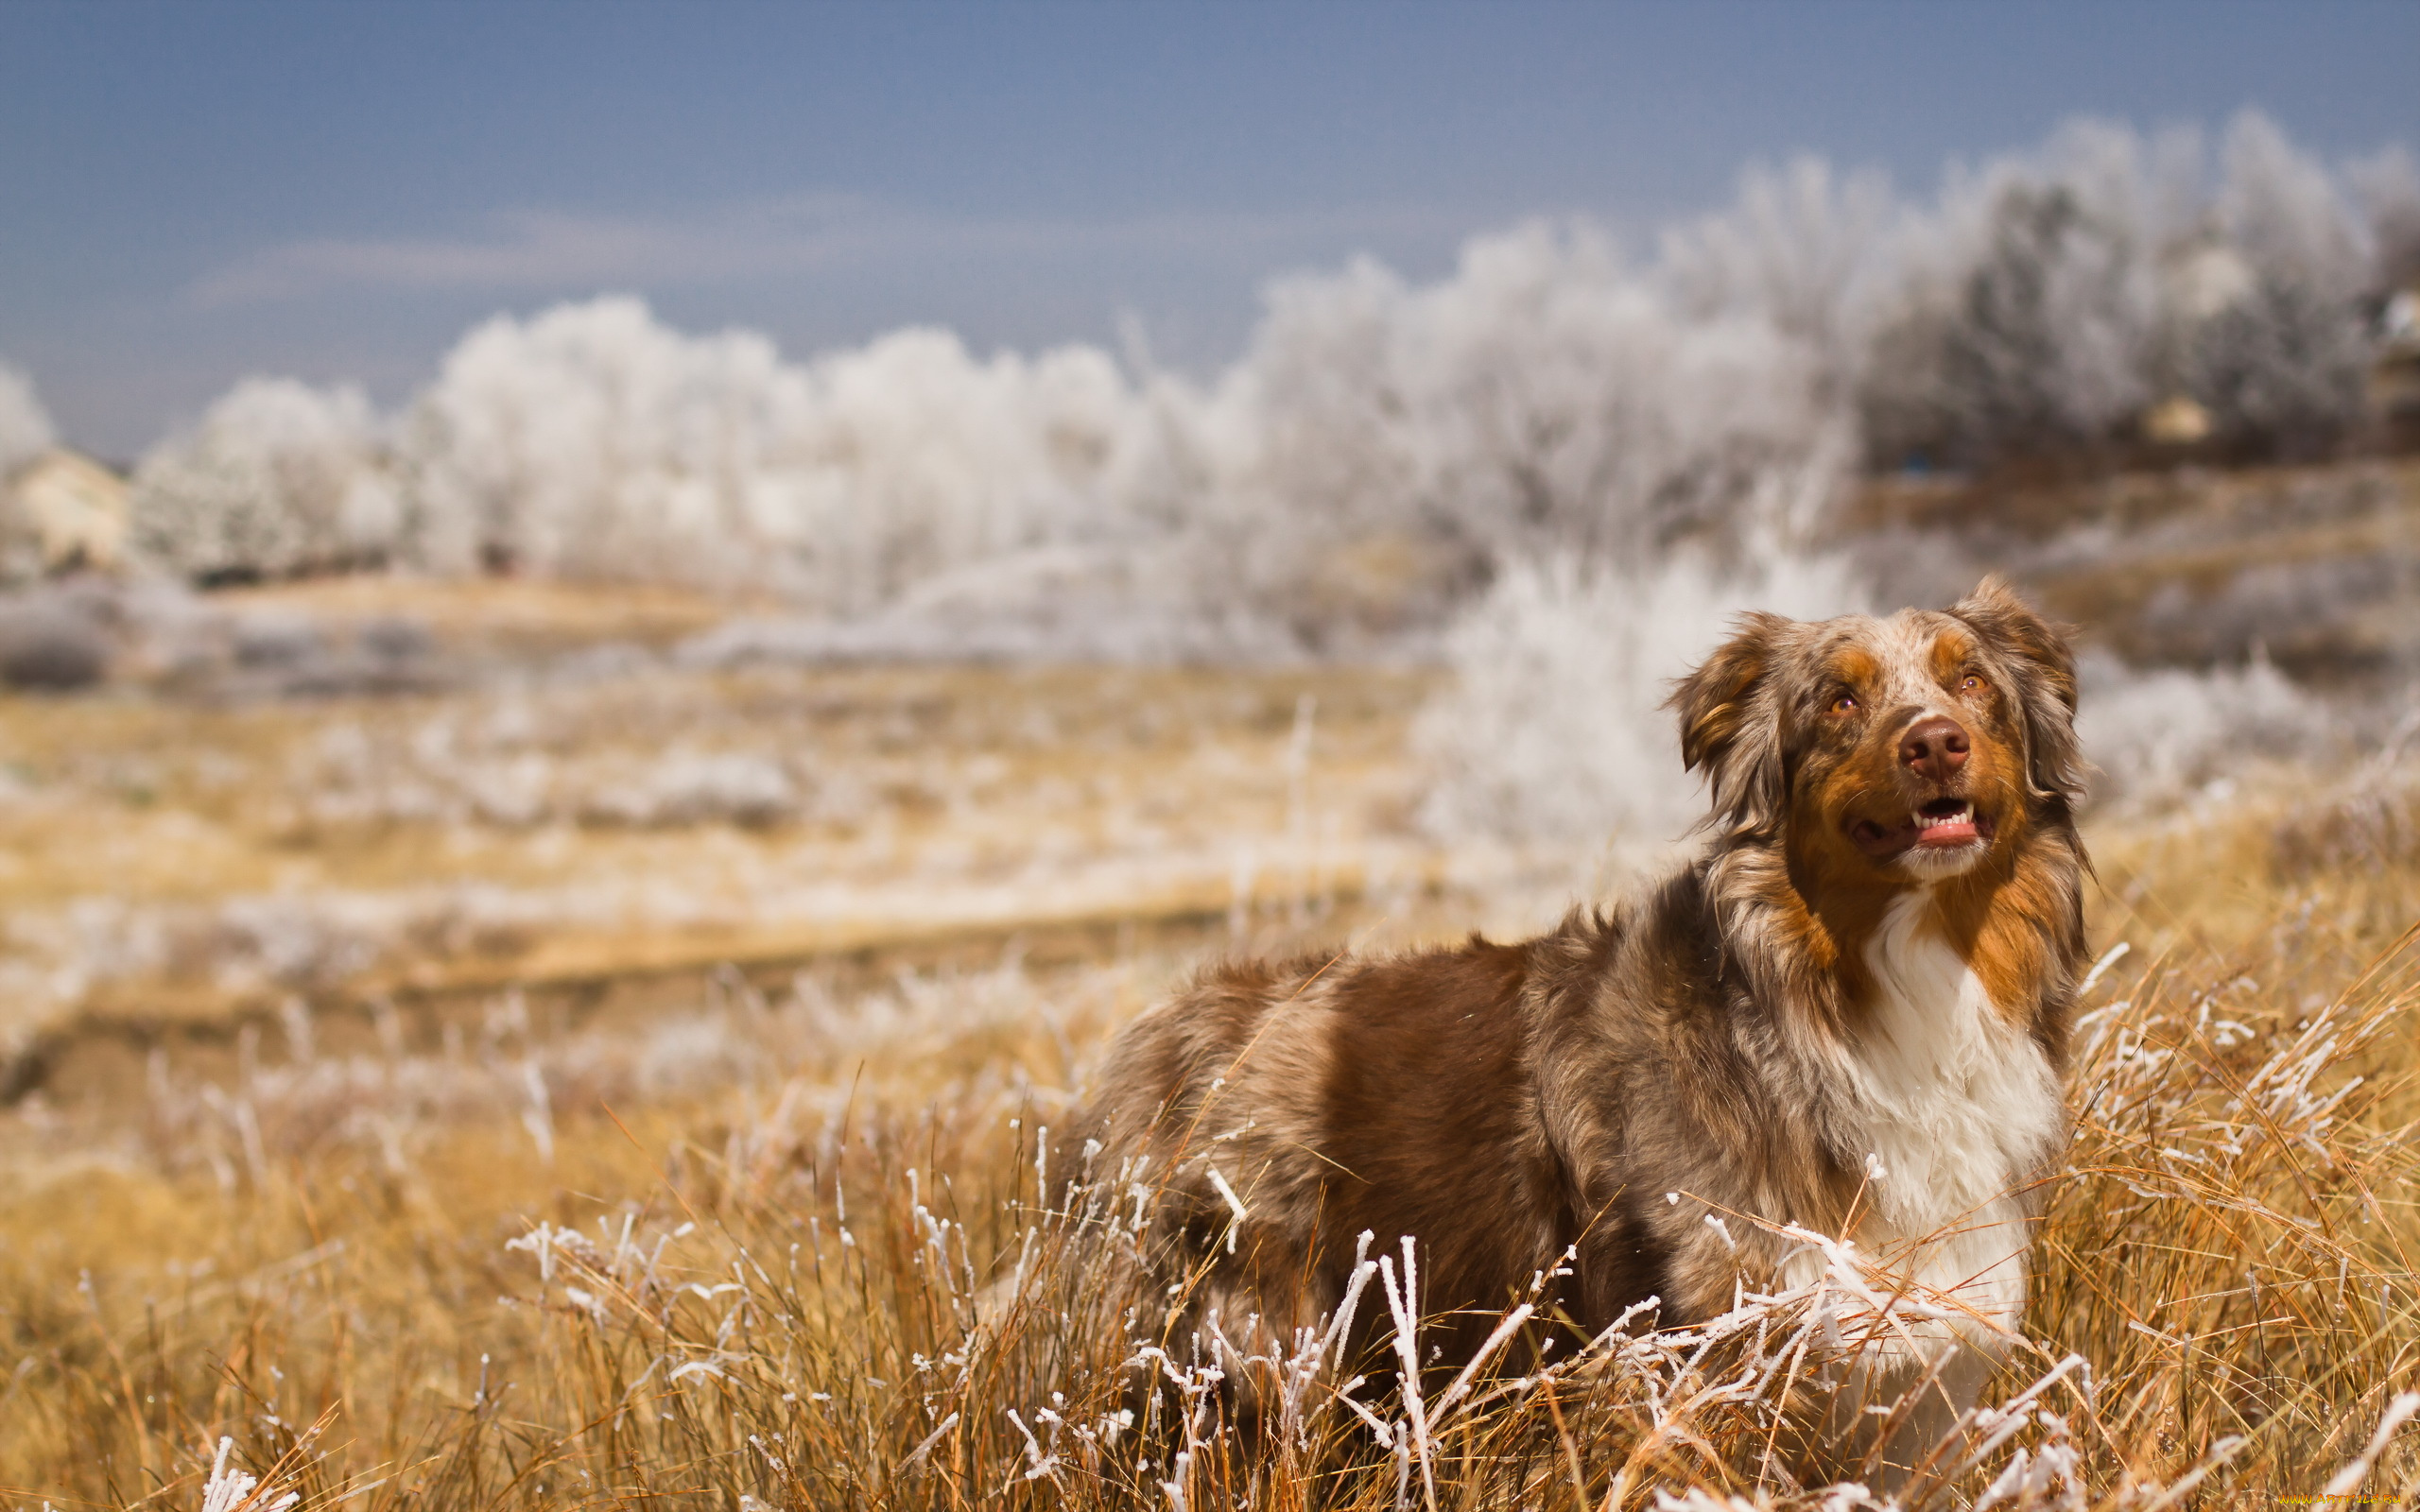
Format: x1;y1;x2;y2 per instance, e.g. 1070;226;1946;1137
0;571;2420;1512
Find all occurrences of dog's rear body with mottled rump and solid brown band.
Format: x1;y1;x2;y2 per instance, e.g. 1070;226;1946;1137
1084;921;1612;1352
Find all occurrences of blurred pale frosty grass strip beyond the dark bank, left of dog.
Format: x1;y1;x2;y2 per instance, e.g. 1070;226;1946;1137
0;580;1438;1045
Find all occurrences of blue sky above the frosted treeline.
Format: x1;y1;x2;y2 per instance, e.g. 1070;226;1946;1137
0;0;2420;457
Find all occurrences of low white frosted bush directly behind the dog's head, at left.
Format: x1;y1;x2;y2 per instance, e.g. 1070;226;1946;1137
1413;557;1866;854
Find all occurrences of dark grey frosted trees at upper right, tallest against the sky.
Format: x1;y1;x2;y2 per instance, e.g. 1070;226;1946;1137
1863;112;2415;465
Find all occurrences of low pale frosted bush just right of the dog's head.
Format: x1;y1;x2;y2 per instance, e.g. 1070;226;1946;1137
2076;653;2330;805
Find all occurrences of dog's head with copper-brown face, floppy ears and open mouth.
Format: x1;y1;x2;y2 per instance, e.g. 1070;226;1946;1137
1672;578;2083;883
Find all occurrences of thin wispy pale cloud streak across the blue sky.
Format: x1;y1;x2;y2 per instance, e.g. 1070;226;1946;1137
186;196;1471;307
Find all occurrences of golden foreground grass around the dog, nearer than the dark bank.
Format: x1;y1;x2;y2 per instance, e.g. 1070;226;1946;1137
0;745;2420;1509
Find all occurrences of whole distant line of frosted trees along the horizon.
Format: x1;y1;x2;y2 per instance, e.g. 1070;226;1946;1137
0;113;2420;641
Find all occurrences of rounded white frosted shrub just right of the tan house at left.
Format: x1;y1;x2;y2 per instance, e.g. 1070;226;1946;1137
129;377;399;578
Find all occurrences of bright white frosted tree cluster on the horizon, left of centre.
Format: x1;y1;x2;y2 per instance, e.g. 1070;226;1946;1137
414;300;1161;612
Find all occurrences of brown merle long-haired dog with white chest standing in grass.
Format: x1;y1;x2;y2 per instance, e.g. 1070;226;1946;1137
1075;578;2088;1456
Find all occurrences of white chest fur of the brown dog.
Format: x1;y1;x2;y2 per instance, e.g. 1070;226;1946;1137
1841;888;2065;1326
